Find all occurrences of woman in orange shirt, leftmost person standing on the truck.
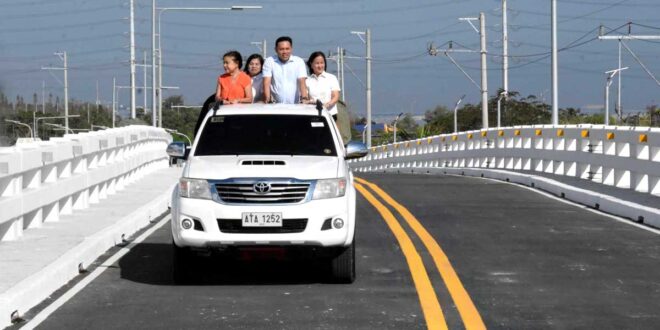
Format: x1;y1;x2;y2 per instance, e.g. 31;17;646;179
215;50;252;104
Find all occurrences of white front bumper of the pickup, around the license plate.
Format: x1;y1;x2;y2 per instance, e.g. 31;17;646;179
172;187;355;248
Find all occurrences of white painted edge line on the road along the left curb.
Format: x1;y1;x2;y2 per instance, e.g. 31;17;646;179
21;215;171;330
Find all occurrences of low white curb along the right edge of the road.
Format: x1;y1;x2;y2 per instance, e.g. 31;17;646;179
383;167;660;228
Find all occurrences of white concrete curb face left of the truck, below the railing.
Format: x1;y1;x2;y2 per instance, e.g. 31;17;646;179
0;190;171;327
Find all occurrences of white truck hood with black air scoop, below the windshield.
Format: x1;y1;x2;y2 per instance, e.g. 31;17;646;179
183;155;343;180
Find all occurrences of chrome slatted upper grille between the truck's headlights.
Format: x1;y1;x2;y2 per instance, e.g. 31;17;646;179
215;182;309;204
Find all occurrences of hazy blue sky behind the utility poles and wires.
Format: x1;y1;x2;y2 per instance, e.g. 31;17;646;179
0;0;660;116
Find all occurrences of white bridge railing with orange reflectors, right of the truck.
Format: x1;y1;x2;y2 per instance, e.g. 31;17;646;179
351;125;660;195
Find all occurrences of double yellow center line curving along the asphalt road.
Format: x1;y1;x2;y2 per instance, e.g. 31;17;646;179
355;178;486;329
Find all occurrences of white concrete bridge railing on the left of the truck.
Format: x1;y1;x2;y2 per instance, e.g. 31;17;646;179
0;126;172;241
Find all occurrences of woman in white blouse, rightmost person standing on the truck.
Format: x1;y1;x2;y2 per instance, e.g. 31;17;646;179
305;52;339;120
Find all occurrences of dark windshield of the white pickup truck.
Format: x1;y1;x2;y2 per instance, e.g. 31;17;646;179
195;115;337;156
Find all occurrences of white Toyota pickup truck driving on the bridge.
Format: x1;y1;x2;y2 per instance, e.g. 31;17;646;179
168;104;367;283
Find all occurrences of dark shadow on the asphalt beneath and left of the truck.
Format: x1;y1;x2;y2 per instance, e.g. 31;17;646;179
119;243;329;285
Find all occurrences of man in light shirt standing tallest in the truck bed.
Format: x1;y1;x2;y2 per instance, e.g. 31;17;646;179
263;36;309;103
